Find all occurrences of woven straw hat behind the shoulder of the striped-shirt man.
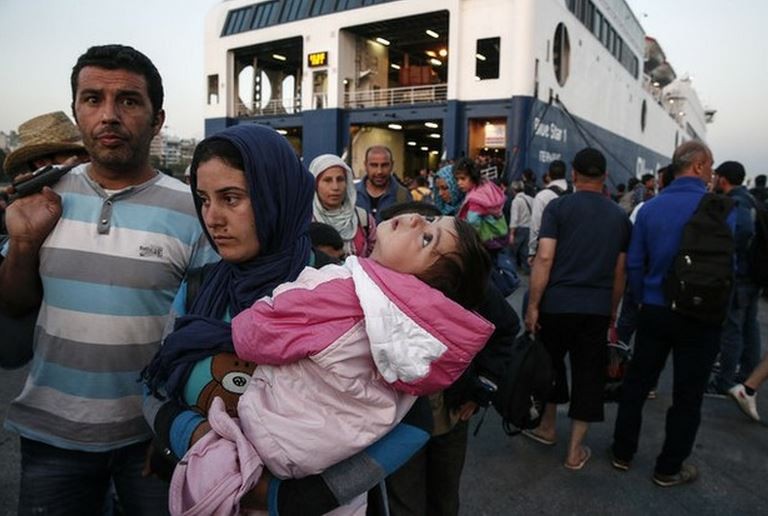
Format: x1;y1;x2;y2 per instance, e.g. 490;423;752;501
3;111;85;177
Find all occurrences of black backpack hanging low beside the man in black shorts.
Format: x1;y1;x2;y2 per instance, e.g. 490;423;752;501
491;333;555;435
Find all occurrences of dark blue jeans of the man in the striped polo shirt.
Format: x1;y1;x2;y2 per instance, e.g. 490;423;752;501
19;437;168;516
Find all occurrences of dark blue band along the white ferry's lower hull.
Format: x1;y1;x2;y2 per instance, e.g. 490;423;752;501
206;96;670;189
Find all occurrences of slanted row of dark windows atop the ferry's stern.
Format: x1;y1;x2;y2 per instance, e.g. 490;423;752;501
221;0;392;36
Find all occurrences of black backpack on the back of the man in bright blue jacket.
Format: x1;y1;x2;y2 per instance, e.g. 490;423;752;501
663;193;734;325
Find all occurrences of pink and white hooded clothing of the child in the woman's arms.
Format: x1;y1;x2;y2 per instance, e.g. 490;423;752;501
170;257;493;514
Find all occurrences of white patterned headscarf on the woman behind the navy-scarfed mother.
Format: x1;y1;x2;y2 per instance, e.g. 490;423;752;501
309;154;358;242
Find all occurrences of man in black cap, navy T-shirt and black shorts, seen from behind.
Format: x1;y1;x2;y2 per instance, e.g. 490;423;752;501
525;148;631;470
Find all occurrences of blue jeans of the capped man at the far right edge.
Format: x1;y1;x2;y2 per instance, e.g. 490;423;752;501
715;281;761;392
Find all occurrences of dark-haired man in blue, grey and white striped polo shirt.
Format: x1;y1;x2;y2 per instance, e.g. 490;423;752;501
0;45;214;514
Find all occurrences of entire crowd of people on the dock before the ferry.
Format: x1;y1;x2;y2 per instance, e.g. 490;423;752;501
0;45;768;515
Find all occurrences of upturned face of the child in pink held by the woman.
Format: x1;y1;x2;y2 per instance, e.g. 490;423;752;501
371;214;458;274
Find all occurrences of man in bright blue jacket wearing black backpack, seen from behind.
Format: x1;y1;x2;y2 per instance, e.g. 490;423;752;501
611;141;734;487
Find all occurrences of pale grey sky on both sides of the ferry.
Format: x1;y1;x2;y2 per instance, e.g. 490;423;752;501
0;0;768;175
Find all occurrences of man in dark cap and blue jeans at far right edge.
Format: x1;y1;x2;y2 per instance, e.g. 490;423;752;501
707;161;768;396
